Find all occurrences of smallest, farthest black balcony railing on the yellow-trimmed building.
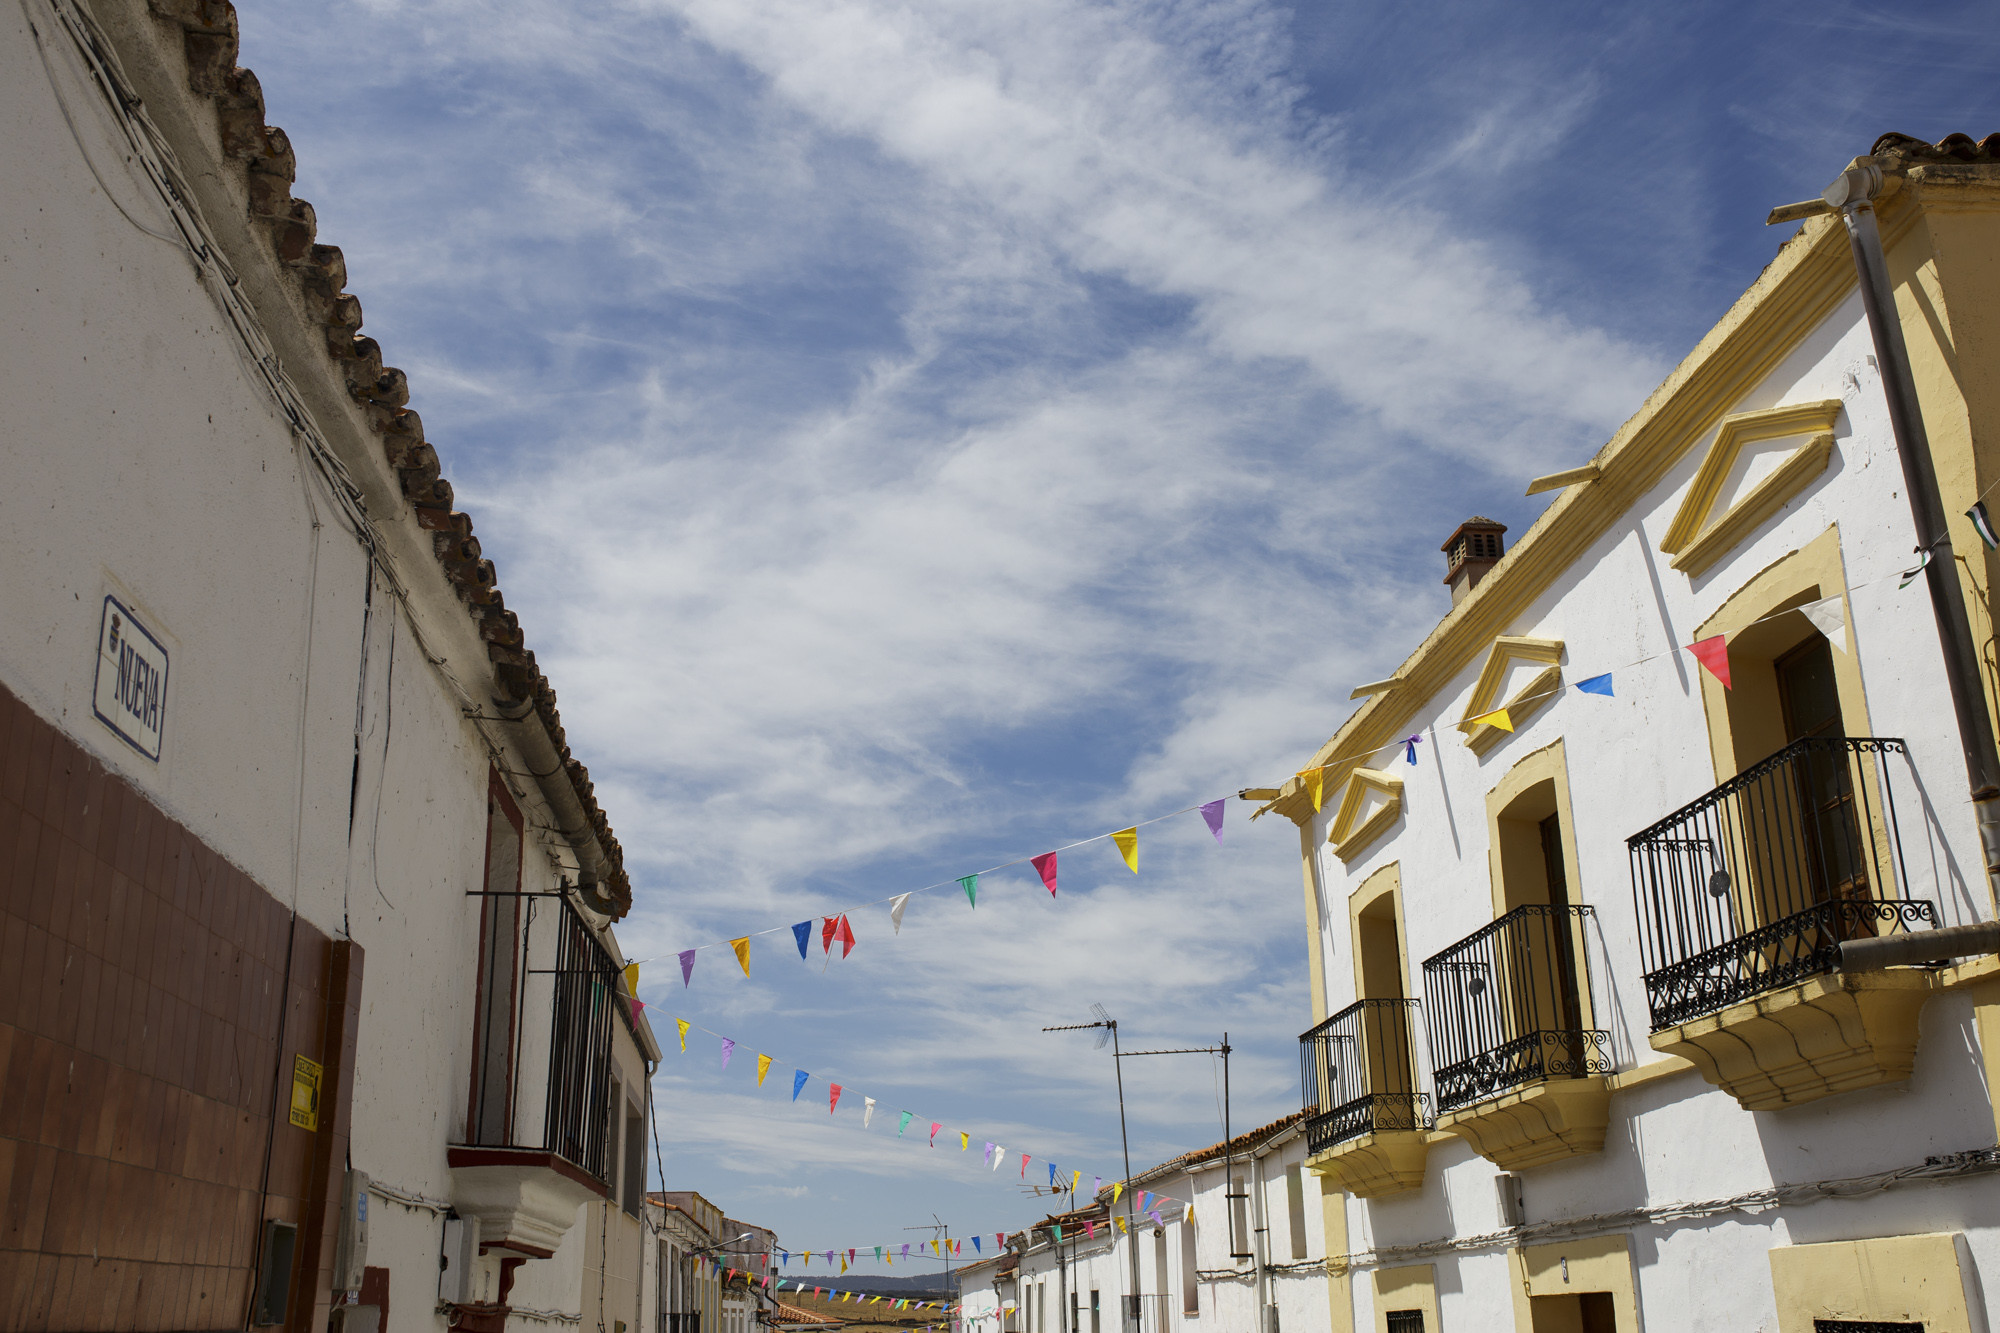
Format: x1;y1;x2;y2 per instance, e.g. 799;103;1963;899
1298;999;1430;1153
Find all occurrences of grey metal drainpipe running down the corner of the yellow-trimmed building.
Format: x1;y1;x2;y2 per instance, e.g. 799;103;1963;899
1820;162;2000;909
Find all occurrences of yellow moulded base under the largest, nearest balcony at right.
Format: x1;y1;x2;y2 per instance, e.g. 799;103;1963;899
1652;967;1938;1111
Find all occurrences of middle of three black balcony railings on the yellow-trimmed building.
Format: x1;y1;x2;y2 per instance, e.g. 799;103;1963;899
1424;903;1612;1111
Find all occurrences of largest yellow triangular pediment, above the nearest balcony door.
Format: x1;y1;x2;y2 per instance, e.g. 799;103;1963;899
1660;398;1840;578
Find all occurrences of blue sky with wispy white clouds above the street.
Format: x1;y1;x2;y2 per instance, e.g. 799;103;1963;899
242;0;2000;1271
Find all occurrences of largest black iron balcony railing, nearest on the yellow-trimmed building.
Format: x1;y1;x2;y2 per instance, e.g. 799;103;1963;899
1626;737;1938;1031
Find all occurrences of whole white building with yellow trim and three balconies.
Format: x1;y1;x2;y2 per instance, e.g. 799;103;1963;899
1260;136;2000;1333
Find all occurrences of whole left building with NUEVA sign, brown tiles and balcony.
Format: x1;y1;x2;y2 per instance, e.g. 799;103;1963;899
0;0;660;1331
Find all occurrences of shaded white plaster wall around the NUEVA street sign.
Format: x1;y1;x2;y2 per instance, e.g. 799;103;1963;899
0;6;648;1329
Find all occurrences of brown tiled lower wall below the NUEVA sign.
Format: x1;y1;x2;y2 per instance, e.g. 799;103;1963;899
0;687;346;1329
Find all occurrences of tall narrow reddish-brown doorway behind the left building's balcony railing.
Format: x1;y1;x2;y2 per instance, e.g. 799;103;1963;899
466;773;522;1145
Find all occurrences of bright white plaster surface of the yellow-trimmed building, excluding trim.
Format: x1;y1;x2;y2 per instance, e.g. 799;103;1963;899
1312;296;2000;1329
